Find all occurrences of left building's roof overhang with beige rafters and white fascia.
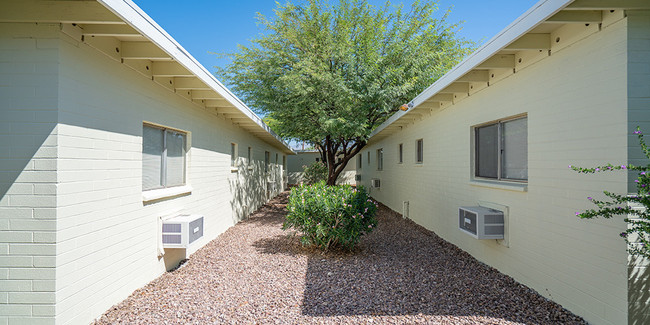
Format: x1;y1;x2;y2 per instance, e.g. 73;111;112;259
0;0;295;154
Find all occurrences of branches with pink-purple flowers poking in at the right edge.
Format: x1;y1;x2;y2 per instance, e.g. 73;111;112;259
569;127;650;258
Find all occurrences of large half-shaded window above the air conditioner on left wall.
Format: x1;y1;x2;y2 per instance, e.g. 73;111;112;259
142;125;187;191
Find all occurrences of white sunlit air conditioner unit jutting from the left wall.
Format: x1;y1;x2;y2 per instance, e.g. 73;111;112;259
162;214;203;248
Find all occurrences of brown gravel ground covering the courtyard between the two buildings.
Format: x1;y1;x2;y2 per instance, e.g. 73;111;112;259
95;192;585;324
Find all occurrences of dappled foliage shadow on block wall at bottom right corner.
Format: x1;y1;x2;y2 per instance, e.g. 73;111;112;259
628;256;650;325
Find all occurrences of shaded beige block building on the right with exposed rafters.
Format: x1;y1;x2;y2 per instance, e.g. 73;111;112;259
357;0;650;324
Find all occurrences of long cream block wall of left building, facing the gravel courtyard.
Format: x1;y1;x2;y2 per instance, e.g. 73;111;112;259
56;31;283;324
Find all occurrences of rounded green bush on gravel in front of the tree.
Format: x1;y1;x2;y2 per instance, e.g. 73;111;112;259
282;182;377;251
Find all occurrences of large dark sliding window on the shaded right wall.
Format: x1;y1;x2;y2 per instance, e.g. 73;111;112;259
474;117;528;181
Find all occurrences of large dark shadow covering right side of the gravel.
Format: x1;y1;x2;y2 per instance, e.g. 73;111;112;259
254;202;576;324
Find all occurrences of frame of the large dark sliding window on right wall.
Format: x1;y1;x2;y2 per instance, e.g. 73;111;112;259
472;114;528;184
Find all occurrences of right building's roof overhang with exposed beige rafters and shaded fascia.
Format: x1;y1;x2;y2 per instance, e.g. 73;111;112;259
368;0;650;143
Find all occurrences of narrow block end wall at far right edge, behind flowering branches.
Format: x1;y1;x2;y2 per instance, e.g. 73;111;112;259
627;11;650;324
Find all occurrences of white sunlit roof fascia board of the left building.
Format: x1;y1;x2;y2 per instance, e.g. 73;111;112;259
97;0;295;154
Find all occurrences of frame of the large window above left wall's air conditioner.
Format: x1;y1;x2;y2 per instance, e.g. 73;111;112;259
141;122;189;192
